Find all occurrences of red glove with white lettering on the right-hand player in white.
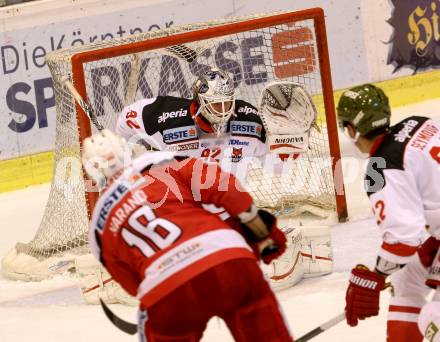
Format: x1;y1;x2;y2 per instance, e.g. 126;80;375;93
345;265;385;327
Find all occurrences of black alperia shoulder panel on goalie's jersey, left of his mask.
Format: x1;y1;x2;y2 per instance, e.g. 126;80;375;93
142;96;194;135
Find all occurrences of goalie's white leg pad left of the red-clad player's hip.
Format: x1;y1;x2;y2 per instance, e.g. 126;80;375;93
75;254;139;306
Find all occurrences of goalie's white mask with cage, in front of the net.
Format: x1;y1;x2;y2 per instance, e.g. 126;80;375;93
192;68;235;131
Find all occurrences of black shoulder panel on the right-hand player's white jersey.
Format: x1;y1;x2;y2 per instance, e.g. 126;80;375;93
365;116;429;196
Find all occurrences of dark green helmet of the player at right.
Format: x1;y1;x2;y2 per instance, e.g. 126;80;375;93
337;84;391;136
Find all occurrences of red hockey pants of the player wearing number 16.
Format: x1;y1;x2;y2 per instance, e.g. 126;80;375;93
139;259;292;342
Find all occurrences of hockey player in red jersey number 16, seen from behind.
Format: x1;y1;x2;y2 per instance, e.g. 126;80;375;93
83;130;292;342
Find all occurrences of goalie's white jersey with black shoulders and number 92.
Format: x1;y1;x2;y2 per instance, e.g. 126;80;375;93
116;96;268;176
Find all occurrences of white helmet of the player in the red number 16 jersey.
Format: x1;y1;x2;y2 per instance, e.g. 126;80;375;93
82;129;130;187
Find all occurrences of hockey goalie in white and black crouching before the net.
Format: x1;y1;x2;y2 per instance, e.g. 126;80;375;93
77;69;332;302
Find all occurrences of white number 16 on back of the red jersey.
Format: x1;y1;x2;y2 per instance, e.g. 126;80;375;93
121;206;182;258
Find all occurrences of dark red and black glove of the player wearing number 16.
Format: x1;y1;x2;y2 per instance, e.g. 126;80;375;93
239;205;287;264
